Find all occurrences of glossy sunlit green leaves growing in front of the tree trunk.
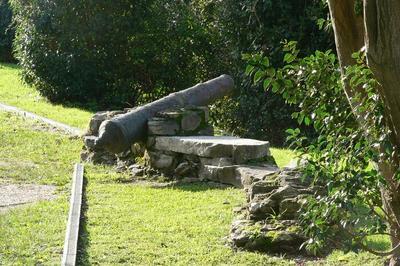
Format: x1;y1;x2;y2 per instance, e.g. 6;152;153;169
246;42;393;255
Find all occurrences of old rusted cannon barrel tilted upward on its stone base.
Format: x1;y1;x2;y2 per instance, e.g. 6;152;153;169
95;75;234;153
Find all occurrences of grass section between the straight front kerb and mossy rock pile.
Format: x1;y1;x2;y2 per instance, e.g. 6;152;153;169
80;182;293;265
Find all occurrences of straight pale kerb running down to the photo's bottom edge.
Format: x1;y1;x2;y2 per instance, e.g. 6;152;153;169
61;163;84;266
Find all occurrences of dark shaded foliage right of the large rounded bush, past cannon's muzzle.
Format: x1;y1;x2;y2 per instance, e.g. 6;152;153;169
209;0;334;145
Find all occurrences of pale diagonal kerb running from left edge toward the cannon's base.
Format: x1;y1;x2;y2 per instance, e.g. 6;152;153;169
0;103;83;136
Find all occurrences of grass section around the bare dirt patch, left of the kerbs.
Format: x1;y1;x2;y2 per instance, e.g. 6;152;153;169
0;112;81;265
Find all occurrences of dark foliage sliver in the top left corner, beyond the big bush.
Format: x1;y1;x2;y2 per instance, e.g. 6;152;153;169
0;0;15;62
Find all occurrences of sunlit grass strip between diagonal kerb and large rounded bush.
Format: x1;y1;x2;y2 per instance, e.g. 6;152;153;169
0;63;92;129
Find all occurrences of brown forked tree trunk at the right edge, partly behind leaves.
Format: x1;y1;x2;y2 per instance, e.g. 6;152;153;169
328;0;400;266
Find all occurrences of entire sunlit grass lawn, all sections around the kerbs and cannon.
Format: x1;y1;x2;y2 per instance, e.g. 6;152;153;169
0;68;388;265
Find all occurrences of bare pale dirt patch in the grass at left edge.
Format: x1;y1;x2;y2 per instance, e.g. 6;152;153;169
0;184;56;213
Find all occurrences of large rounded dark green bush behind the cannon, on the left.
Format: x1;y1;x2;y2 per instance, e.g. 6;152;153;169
13;0;225;108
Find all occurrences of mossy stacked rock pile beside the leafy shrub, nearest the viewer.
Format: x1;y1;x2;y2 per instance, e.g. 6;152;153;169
231;161;317;254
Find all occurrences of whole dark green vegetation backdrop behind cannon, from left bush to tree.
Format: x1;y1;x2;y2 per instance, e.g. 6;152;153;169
4;0;334;145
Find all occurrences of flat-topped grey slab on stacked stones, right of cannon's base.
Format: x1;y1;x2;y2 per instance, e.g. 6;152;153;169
147;127;279;188
